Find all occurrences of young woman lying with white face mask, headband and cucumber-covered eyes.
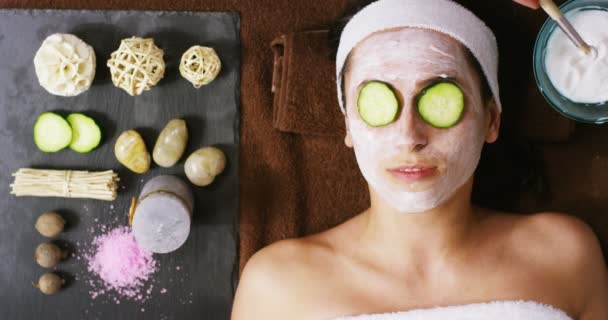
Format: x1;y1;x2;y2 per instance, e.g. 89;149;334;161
232;0;608;320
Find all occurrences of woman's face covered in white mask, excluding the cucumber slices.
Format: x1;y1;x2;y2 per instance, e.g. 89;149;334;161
344;28;500;212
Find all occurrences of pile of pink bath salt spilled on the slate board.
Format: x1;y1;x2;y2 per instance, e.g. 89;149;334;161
86;227;157;298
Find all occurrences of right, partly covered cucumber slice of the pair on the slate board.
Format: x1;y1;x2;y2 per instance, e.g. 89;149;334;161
68;113;101;153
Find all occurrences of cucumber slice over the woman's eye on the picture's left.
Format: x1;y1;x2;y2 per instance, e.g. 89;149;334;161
357;81;399;127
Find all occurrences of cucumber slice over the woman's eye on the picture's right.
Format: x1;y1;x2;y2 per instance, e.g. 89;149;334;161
418;81;464;128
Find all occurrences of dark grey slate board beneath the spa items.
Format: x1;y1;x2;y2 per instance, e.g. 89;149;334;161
0;10;240;319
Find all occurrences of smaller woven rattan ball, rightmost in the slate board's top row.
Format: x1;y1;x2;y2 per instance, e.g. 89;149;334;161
179;46;222;89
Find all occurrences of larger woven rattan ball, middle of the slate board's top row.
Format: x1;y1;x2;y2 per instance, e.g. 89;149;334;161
108;37;165;96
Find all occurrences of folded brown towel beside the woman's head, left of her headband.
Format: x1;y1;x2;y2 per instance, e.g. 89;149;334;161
271;30;344;136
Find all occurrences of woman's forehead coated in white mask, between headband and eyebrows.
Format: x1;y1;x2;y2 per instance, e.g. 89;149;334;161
344;27;476;91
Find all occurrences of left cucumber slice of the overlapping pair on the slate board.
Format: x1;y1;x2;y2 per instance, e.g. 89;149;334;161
34;112;72;152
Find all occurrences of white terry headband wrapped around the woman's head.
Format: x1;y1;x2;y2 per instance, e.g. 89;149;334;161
336;0;502;113
